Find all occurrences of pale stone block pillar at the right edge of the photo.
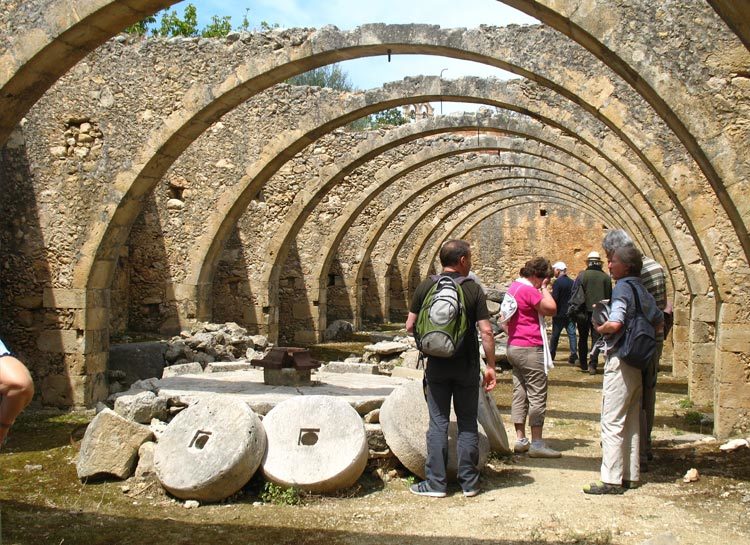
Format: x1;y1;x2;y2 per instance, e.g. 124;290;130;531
714;303;750;437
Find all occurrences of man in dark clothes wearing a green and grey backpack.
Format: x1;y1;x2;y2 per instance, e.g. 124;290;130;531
406;240;496;498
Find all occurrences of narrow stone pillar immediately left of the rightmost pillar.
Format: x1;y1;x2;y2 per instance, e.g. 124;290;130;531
688;295;716;406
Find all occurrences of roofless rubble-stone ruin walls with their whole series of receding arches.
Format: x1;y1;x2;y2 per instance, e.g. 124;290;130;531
0;0;750;435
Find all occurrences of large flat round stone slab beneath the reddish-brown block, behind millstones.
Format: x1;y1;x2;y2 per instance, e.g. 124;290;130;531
158;369;409;416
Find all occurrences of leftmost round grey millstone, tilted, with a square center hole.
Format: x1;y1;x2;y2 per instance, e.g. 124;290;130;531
154;398;266;501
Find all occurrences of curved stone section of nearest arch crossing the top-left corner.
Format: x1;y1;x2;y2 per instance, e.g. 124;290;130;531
0;0;178;145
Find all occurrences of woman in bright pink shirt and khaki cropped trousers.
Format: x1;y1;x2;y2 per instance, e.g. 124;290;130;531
506;257;561;458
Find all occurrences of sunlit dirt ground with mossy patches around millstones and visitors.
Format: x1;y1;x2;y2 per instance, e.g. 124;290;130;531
0;348;750;545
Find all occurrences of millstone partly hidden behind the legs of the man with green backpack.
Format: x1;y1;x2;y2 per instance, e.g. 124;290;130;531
380;380;490;480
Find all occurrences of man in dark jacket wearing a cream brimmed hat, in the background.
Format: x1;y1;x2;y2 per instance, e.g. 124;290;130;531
576;252;612;375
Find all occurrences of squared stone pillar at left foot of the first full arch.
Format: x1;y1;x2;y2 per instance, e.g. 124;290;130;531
37;288;109;407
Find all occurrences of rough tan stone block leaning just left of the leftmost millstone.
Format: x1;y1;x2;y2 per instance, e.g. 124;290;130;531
76;409;153;480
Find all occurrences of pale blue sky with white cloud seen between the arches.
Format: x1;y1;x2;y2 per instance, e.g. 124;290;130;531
160;0;538;114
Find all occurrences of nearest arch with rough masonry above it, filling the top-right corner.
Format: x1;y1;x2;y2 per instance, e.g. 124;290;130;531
501;0;750;258
